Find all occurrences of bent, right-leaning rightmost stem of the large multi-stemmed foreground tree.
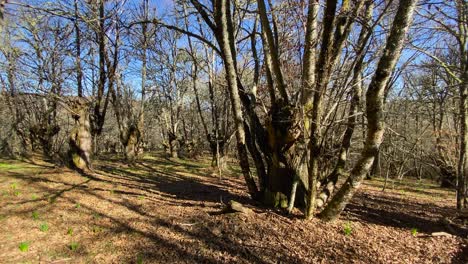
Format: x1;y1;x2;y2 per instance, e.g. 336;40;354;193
320;0;417;221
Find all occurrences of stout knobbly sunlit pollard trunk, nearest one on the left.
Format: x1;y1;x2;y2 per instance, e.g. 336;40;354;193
69;98;92;172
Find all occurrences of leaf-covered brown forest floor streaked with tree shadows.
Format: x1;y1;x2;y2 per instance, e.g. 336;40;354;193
0;152;468;263
